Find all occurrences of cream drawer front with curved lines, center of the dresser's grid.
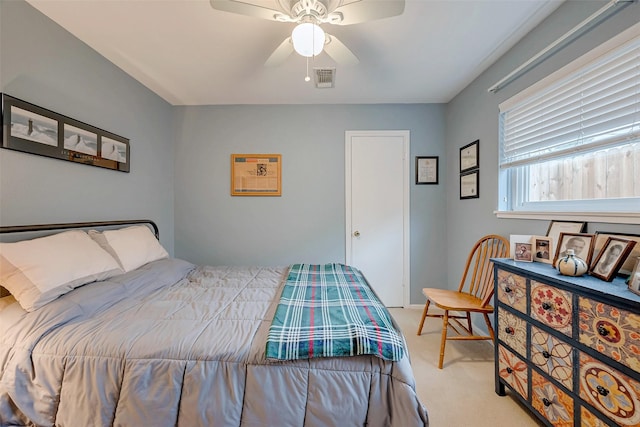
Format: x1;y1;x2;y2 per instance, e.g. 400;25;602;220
531;326;573;390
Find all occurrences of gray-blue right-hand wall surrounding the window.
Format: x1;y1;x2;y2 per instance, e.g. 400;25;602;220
445;0;640;287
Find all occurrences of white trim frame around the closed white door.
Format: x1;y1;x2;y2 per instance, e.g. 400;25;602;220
344;130;411;307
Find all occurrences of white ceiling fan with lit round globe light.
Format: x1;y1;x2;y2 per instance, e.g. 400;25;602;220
210;0;405;66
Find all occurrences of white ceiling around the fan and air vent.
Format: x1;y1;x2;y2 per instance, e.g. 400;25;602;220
27;0;562;105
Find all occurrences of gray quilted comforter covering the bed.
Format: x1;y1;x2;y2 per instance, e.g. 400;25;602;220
0;259;428;427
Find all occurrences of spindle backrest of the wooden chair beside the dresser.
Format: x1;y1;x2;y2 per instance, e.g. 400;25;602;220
458;234;509;307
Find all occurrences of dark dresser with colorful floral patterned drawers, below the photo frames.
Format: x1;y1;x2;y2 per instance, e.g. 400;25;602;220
494;259;640;427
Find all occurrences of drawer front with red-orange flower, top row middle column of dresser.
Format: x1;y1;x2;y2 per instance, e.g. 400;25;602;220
531;280;573;337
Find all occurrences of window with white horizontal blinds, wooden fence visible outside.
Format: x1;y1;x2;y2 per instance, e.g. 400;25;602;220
499;25;640;217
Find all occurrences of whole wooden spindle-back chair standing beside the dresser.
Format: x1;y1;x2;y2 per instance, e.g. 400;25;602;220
418;234;509;369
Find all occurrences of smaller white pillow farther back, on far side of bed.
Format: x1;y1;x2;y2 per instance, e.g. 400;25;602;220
89;225;169;272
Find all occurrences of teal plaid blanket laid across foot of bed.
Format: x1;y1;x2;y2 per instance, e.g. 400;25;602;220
266;264;405;361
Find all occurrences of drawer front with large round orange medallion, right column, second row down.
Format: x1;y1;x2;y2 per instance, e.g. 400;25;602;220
580;353;640;426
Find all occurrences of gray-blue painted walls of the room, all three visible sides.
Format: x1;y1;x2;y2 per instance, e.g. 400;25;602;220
0;0;640;304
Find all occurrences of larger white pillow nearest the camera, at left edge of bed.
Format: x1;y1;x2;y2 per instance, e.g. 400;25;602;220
0;230;123;311
